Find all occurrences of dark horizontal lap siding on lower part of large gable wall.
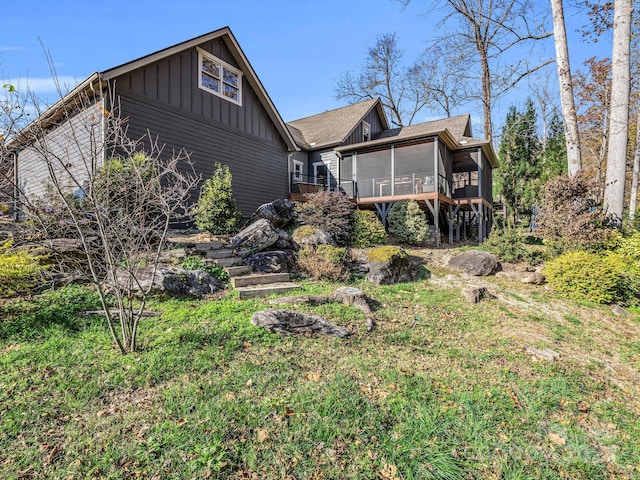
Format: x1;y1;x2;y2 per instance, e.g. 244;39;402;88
120;92;289;216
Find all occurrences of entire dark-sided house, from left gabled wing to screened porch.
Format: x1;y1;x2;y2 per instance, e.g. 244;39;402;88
12;27;497;242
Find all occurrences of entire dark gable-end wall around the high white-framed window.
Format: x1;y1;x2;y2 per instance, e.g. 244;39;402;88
110;38;289;216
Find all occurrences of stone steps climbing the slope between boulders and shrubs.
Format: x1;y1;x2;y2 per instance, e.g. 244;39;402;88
196;242;300;299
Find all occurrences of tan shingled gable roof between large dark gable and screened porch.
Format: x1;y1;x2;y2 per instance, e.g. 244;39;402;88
287;98;389;149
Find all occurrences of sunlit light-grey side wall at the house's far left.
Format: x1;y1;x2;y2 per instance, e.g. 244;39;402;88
18;101;105;200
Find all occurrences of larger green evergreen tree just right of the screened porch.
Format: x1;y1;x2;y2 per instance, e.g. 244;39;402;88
496;98;542;224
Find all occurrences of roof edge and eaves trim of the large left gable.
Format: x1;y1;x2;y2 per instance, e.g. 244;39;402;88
9;27;299;151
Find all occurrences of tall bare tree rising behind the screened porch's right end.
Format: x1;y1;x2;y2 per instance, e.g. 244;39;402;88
400;0;553;139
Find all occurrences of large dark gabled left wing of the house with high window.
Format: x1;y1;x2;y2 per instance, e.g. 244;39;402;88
8;27;298;215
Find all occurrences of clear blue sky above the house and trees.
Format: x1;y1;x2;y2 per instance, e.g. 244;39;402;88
0;0;610;134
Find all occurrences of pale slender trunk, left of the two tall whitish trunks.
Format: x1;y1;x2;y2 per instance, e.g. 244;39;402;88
551;0;582;177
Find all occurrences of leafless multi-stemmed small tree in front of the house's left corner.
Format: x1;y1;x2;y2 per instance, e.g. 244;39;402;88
4;85;198;354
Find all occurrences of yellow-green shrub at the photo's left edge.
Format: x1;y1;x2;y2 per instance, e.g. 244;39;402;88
0;240;44;297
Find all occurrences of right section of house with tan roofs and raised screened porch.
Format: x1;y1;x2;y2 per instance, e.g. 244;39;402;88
287;99;498;243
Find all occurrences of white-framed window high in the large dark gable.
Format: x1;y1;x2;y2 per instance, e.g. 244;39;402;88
198;48;242;105
